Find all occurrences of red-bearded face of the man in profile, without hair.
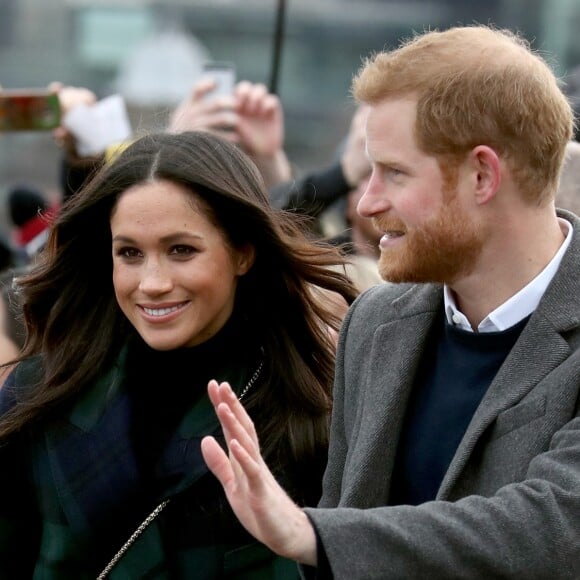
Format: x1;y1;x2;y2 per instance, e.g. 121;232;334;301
358;98;483;283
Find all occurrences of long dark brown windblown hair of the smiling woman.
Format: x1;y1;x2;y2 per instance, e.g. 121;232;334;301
0;132;357;476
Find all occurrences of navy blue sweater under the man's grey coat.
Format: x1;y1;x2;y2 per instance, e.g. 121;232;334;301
389;316;529;505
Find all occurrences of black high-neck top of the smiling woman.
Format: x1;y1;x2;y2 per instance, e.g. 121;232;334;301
127;316;260;495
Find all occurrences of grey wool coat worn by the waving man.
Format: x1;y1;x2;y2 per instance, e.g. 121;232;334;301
306;212;580;580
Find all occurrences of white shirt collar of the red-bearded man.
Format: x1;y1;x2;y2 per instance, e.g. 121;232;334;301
443;218;572;332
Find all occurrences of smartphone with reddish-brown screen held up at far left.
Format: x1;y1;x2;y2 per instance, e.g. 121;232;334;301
0;89;61;131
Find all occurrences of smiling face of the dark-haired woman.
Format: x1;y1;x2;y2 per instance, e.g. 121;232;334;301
111;181;253;350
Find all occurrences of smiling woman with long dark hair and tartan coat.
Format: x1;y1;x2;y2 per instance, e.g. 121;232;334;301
0;132;356;580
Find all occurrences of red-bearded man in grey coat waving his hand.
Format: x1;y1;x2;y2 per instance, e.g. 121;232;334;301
202;26;580;580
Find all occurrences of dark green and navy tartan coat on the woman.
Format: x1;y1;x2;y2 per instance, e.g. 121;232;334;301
0;346;298;580
